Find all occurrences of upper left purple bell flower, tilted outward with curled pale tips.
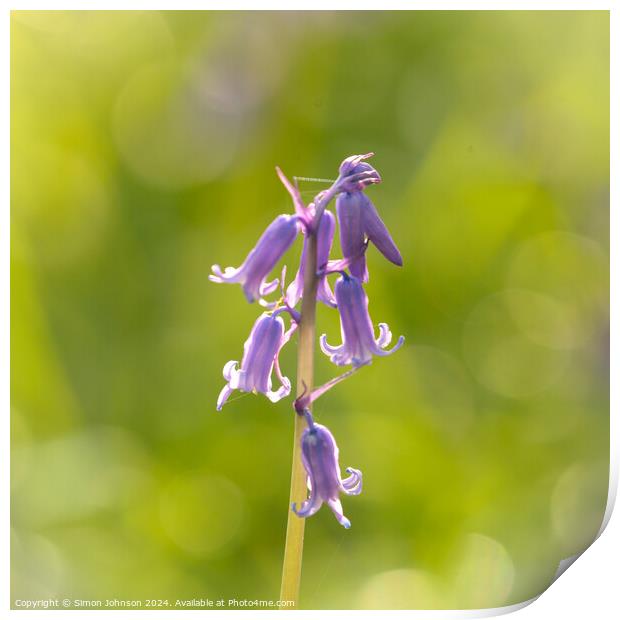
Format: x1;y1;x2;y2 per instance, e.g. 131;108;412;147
209;215;299;302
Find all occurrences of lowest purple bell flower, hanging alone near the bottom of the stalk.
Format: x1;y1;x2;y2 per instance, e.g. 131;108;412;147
292;411;362;529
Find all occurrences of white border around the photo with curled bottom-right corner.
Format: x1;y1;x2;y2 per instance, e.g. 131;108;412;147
0;0;620;620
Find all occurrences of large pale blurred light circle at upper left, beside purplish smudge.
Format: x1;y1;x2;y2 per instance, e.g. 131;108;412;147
113;60;241;189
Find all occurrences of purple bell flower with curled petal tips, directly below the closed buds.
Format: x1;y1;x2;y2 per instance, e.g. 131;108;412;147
320;273;405;367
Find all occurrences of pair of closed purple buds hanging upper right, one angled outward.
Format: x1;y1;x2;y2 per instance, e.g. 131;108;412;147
336;191;403;282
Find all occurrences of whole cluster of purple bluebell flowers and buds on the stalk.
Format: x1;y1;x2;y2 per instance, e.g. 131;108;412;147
209;153;404;528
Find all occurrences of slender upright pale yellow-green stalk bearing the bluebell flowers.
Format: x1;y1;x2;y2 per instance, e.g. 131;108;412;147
280;226;317;609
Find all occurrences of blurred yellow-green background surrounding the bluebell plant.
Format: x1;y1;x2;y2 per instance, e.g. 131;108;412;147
11;11;609;608
